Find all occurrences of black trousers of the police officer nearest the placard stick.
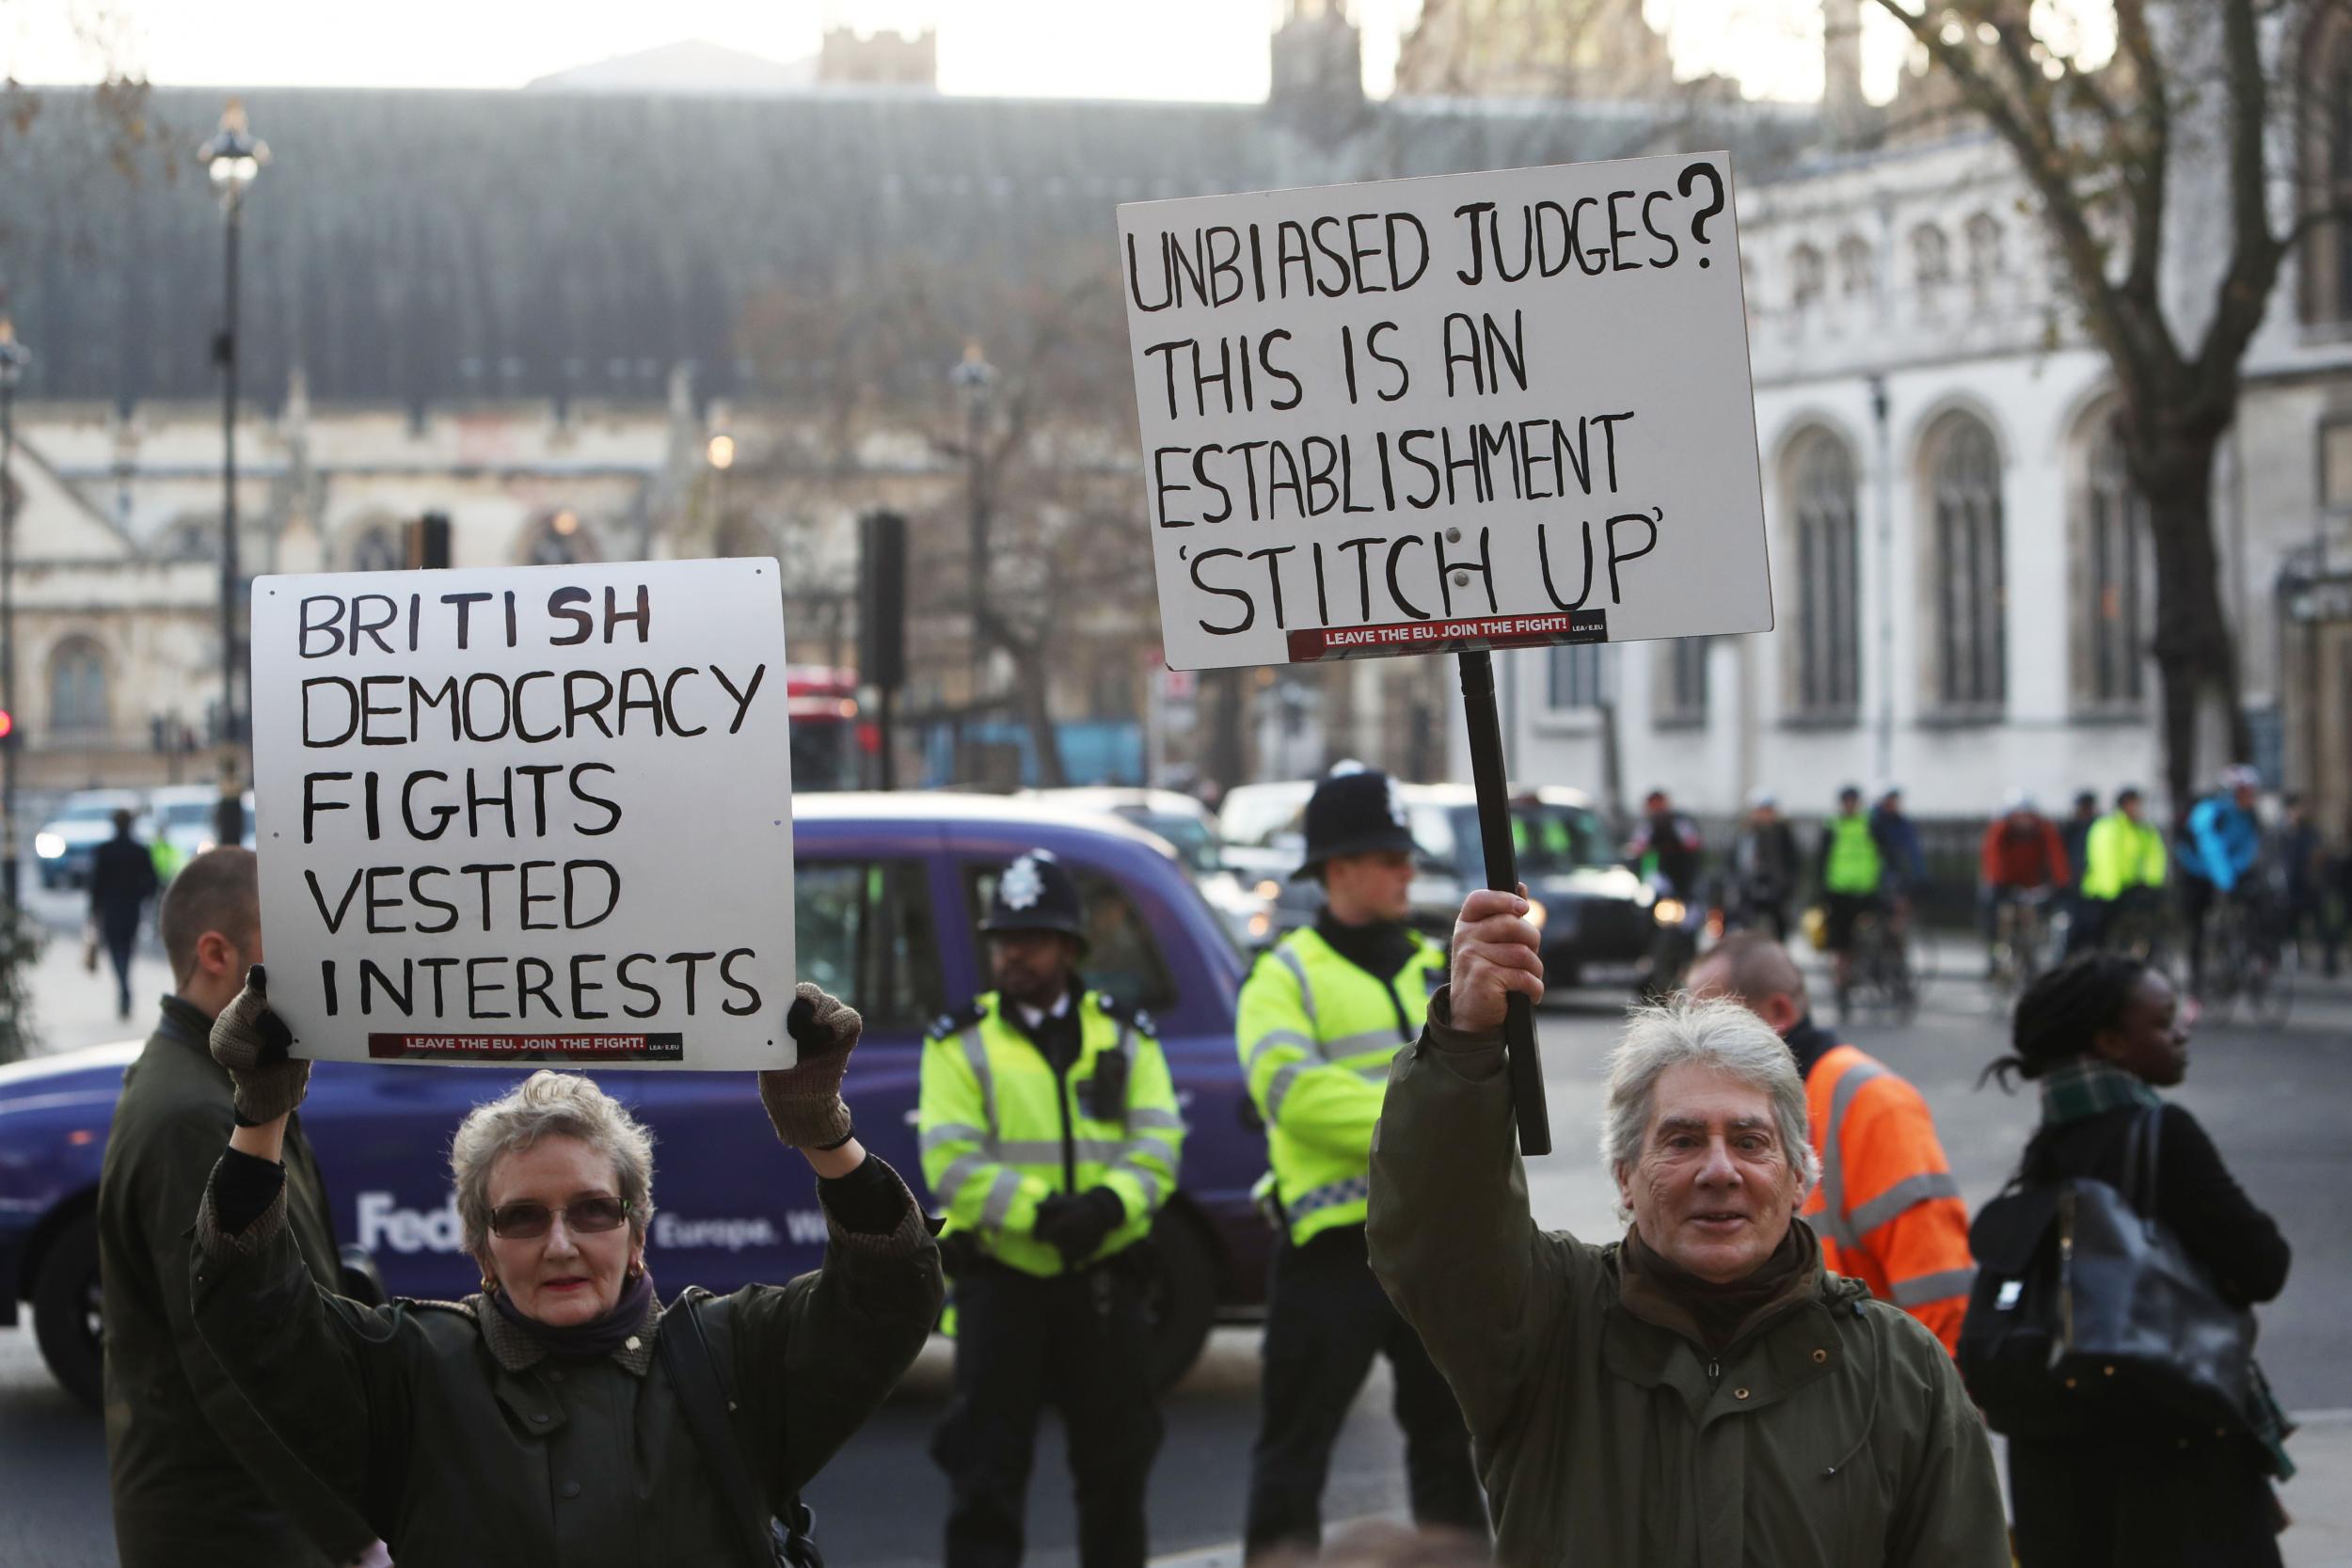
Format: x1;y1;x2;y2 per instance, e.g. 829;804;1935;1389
1242;1225;1486;1557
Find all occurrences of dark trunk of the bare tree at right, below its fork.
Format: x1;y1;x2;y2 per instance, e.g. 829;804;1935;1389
2134;433;2253;818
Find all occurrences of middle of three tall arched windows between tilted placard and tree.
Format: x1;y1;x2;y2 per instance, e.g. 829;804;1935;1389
1924;414;2009;707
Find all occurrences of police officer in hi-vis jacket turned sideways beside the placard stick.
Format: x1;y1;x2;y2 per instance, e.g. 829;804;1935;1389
1237;768;1486;1557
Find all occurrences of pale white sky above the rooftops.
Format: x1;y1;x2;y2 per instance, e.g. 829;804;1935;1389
0;0;1929;101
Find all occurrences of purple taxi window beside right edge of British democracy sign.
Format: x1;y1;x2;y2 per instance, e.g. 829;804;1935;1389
793;861;946;1035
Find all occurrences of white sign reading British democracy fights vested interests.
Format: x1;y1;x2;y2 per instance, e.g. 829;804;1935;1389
252;560;793;1069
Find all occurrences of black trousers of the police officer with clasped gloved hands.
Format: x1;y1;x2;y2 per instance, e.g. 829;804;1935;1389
931;1256;1160;1568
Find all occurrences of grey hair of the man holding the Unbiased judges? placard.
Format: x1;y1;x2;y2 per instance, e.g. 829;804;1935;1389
1602;992;1820;1196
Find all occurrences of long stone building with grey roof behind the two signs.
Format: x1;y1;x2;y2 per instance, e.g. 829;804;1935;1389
0;27;1816;787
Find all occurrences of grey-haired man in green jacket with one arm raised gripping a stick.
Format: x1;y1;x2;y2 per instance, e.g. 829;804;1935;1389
1372;891;2009;1568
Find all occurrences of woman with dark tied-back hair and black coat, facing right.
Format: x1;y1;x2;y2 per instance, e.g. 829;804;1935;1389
1985;955;2294;1568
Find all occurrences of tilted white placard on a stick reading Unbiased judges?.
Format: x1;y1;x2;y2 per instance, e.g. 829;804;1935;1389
1120;152;1772;670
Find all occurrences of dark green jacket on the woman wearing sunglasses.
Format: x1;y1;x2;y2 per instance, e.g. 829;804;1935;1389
193;1154;941;1568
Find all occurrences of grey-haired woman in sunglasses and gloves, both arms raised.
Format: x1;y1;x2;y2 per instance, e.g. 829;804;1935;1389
193;966;941;1568
